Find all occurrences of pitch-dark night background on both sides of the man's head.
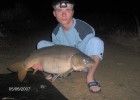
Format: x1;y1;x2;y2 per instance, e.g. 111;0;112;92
0;0;139;34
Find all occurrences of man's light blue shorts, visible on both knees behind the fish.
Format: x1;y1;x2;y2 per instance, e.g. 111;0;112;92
37;37;104;59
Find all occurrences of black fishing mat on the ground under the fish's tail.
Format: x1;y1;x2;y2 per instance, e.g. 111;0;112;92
0;72;68;100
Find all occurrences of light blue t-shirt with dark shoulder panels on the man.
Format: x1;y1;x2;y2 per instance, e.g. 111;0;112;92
52;18;95;51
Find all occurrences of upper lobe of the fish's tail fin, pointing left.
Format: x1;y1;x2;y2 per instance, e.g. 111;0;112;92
7;61;24;72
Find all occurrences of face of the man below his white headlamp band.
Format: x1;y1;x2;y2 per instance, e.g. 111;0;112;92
53;7;74;25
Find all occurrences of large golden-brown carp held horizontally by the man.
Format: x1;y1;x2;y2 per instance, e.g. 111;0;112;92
8;45;95;81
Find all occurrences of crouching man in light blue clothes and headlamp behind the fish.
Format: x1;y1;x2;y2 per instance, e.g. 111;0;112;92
37;0;104;93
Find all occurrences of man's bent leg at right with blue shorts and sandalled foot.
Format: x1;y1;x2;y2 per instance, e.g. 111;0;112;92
85;37;104;93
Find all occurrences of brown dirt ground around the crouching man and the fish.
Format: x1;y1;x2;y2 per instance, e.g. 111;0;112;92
0;28;140;100
